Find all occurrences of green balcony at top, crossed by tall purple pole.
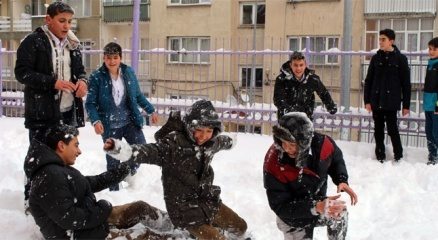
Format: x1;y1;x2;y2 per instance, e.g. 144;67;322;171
103;0;150;23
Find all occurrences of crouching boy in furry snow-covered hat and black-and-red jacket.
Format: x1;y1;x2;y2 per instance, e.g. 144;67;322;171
263;112;357;240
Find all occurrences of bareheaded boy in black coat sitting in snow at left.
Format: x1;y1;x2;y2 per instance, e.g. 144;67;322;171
24;125;169;239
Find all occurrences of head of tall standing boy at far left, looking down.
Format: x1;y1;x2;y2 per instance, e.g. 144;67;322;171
46;1;75;40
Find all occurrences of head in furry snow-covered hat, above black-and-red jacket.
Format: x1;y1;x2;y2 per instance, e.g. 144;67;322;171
272;112;313;167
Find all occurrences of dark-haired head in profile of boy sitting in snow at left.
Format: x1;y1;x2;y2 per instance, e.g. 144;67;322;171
46;124;81;165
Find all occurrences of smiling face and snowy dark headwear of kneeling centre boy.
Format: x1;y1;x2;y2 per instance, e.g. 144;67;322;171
184;100;222;145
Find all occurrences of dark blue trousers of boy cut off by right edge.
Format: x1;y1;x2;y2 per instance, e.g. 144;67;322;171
424;111;438;161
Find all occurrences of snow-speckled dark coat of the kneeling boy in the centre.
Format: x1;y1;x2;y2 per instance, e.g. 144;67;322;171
112;121;233;228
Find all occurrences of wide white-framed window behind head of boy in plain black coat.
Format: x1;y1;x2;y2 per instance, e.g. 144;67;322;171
365;18;434;56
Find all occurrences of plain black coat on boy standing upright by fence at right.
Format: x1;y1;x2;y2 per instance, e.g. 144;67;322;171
364;45;411;111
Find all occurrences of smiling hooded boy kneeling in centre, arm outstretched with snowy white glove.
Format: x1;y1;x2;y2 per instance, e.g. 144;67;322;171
104;100;247;239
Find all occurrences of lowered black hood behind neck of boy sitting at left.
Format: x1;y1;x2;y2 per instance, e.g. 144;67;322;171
24;139;65;179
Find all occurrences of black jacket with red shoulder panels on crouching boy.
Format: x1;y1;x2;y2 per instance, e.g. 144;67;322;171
263;133;348;227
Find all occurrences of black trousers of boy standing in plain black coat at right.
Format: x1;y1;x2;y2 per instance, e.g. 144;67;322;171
373;109;403;159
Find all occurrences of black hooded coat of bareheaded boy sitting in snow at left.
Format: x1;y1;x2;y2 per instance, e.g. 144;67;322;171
24;140;129;239
